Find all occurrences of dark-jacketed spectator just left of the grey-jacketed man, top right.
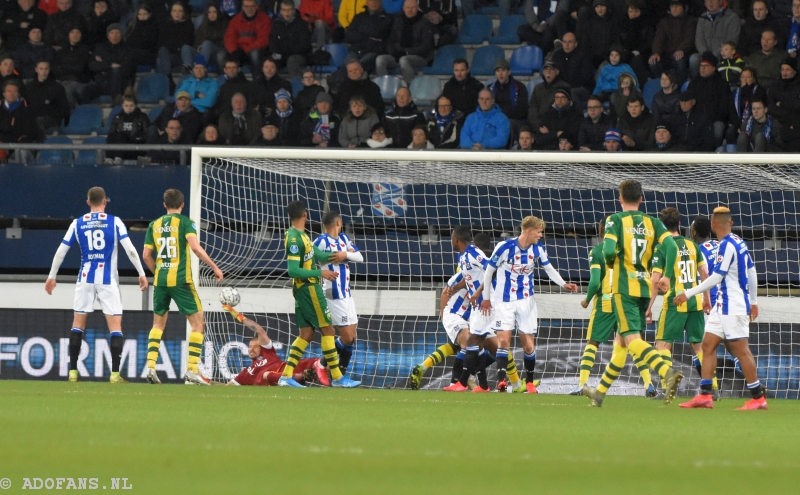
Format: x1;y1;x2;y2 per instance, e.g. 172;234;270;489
648;0;692;86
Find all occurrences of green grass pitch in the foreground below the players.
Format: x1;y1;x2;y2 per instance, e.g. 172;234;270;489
0;381;800;495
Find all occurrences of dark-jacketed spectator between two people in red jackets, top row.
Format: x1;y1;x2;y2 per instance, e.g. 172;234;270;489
269;0;311;77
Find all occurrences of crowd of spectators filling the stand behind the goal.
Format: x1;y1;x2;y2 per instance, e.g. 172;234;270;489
0;0;800;162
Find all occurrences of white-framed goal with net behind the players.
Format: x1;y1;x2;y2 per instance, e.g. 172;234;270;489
190;148;800;398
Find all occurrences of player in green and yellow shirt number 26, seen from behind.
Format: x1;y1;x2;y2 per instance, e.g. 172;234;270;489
142;189;223;385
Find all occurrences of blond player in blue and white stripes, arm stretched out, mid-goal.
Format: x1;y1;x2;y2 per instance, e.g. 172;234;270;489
468;215;578;394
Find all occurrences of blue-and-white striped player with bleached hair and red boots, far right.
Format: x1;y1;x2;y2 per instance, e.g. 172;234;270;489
675;206;767;410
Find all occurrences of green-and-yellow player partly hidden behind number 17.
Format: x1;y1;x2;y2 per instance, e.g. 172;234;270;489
569;219;656;397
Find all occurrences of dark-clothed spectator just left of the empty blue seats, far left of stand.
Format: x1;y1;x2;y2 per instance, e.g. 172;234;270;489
23;60;70;135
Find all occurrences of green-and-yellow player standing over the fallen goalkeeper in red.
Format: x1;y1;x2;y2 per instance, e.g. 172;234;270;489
278;201;361;388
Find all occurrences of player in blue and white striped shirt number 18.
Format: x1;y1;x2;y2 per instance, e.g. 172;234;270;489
44;187;147;383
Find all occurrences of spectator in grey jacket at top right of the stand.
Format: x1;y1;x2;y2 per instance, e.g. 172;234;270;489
689;0;742;78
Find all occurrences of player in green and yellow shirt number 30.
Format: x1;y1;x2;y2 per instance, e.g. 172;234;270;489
646;208;718;389
